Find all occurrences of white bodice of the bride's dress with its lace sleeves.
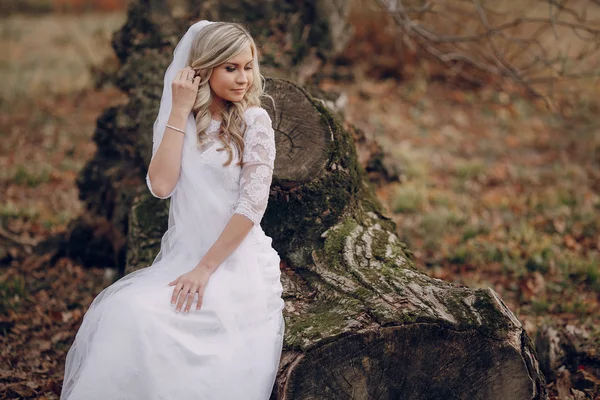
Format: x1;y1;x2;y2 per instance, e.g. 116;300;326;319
146;107;275;252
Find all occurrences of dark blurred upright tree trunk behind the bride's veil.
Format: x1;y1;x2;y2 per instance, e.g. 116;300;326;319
61;0;351;274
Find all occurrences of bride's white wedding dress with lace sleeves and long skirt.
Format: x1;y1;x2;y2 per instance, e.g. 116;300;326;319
61;107;284;400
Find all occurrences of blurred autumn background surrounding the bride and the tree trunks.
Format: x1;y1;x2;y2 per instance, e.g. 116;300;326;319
0;0;600;399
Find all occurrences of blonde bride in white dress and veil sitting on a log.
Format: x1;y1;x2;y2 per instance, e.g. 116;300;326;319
61;21;285;400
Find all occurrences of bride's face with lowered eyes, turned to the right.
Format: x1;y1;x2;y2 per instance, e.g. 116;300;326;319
208;44;254;106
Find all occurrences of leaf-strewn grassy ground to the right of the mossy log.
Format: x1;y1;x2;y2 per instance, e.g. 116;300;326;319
332;74;600;334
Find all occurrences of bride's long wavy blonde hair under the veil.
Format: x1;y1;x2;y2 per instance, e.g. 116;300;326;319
187;22;270;165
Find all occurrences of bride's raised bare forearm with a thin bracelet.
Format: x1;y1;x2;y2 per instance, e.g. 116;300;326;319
148;112;187;196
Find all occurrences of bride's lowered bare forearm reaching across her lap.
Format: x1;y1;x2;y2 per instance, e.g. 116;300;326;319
198;214;254;273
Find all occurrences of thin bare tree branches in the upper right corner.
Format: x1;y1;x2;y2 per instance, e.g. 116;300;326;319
377;0;600;109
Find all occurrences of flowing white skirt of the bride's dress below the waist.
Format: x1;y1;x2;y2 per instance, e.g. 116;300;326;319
61;229;285;400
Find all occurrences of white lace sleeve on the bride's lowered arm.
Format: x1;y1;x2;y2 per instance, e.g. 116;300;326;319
235;108;275;225
